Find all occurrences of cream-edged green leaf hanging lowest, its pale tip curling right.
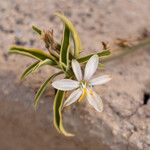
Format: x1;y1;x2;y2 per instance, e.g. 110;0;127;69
53;90;74;136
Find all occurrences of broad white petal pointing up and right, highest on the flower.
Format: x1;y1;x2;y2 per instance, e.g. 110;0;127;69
84;55;99;80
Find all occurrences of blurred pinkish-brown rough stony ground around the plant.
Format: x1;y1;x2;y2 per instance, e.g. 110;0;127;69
0;0;150;150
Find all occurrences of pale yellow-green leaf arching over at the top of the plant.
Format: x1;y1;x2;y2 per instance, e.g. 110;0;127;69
55;13;81;58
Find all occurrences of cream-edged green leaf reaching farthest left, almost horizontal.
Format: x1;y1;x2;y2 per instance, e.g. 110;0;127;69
9;45;55;64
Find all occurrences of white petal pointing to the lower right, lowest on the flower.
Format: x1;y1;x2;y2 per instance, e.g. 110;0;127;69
87;90;103;112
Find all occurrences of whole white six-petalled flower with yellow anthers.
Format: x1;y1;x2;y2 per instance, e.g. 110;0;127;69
52;55;111;112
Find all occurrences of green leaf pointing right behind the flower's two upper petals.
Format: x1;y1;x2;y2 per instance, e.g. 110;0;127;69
77;50;111;63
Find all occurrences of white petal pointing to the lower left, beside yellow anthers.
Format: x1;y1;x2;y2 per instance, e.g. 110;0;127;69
63;89;82;107
